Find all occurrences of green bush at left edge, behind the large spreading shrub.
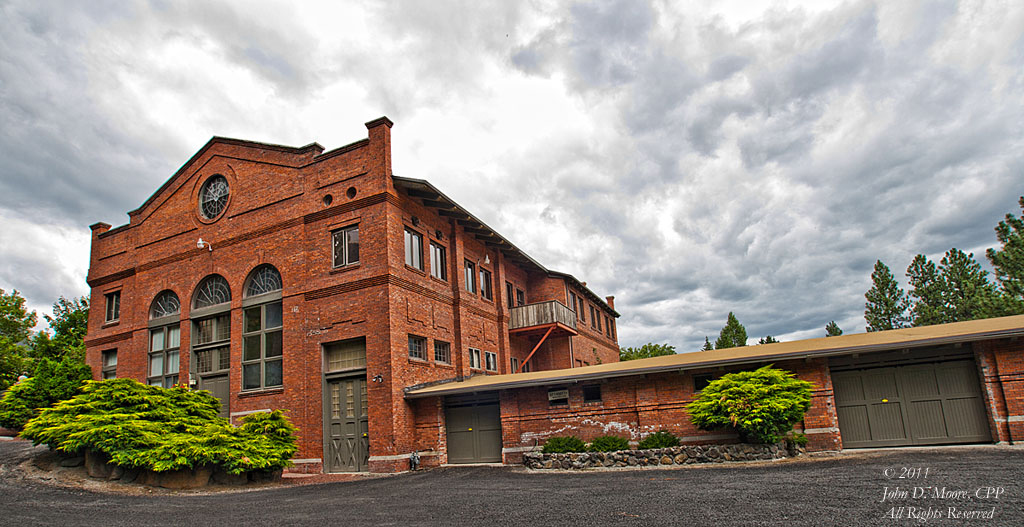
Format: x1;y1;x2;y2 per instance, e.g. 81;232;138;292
0;357;92;430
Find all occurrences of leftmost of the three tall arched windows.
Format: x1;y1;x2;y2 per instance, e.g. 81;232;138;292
146;291;181;388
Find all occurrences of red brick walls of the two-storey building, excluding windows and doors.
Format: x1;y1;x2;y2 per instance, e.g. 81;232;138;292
86;118;618;472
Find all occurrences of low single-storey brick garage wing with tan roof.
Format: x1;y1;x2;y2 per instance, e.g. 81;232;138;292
406;315;1024;463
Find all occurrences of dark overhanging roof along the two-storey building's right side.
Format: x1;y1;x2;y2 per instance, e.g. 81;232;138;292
391;176;620;318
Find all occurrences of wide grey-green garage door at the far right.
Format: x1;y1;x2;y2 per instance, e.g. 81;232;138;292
833;359;991;448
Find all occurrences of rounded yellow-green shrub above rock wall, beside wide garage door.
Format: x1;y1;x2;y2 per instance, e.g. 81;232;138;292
687;365;812;443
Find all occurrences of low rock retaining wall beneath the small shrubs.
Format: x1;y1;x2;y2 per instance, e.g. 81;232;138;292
523;443;800;470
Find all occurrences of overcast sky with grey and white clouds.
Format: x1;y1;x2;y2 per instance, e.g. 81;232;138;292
0;0;1024;351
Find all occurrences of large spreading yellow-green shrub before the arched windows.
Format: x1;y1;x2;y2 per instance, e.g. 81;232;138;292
22;379;297;474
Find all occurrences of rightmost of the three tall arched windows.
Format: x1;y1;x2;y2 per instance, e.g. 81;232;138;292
242;265;284;390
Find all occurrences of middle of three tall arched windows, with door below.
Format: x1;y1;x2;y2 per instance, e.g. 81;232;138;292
189;274;231;416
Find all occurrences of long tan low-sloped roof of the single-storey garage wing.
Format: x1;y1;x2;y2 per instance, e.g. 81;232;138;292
406;315;1024;399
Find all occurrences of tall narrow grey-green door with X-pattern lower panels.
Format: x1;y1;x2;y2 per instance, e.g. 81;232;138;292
324;377;370;472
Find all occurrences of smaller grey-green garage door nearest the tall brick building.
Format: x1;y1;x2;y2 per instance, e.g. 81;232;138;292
444;393;502;464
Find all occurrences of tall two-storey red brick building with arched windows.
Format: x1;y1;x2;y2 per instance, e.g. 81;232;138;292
86;118;618;472
